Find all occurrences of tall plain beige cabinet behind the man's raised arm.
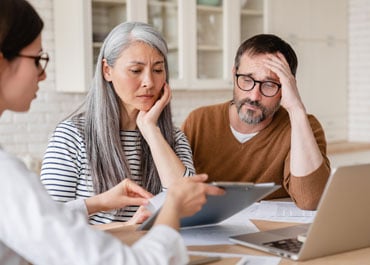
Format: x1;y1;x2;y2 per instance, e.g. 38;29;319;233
266;0;348;142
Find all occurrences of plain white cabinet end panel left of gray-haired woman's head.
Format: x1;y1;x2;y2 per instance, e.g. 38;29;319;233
54;0;93;92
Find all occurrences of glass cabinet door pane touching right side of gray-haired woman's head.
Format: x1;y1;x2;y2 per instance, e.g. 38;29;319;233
148;0;179;79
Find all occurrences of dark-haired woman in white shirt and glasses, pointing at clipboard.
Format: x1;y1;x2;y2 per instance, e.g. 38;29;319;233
0;0;223;265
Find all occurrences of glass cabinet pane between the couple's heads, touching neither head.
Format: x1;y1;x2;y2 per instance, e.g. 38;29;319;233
196;0;224;79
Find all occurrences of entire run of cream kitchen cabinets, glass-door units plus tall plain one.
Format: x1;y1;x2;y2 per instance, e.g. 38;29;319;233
54;0;348;142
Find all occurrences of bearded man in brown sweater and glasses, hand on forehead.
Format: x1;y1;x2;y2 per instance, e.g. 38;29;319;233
182;34;330;210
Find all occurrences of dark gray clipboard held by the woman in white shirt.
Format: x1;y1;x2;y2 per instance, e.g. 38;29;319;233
137;182;281;230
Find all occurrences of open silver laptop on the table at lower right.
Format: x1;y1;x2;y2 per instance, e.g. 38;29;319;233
229;164;370;260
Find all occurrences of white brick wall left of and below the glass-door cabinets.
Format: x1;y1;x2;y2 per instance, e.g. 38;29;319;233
0;0;232;168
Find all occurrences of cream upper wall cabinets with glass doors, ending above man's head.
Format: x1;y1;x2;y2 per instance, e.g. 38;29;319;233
54;0;267;92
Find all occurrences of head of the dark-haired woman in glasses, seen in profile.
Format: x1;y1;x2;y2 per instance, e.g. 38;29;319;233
0;1;49;111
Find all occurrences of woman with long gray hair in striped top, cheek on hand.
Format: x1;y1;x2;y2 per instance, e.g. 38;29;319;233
41;22;195;224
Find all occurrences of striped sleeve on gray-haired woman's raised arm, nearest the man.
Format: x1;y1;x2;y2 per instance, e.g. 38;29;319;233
175;129;195;177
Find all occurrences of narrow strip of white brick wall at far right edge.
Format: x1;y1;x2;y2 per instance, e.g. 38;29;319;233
348;0;370;142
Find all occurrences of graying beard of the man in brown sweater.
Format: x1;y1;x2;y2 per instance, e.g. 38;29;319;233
233;95;280;125
